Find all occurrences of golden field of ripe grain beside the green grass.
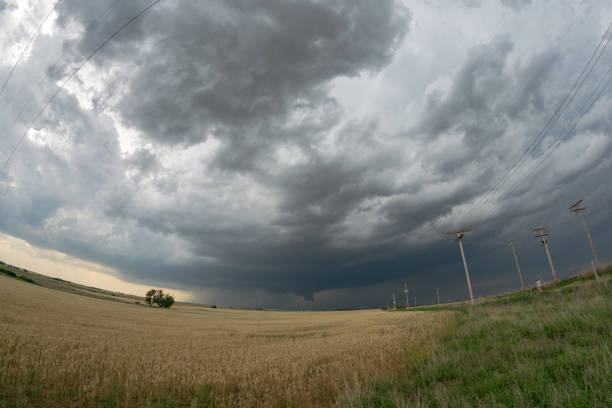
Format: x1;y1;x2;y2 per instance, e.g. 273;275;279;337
0;277;453;407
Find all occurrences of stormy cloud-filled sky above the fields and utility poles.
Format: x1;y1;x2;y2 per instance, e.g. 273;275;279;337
0;0;612;310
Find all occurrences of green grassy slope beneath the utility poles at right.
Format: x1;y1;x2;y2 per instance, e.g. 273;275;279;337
342;276;612;407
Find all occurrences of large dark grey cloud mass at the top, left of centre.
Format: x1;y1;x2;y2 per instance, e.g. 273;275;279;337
55;1;408;154
